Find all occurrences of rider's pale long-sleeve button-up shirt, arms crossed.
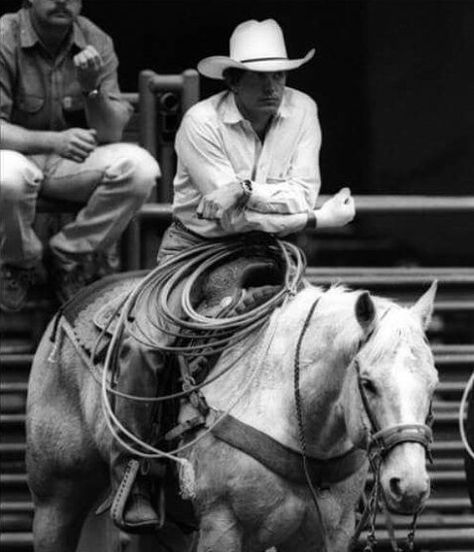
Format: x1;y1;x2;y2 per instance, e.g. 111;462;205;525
173;87;321;238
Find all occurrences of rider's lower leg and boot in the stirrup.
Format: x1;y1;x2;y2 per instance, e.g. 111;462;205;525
110;337;168;533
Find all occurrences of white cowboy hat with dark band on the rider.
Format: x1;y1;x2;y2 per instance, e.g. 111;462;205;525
198;19;314;79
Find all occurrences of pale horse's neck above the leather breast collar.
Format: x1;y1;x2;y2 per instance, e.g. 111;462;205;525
205;292;354;457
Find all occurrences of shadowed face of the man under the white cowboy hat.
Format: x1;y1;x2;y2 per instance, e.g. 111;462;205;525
231;71;286;120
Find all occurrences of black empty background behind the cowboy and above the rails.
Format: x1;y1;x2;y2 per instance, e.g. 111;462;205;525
0;0;474;265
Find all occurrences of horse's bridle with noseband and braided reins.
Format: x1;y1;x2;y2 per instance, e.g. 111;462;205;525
294;296;433;552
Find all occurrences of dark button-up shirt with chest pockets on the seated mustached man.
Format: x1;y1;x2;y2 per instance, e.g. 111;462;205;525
0;8;131;131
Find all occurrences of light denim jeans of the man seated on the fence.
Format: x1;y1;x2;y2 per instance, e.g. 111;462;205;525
0;143;160;268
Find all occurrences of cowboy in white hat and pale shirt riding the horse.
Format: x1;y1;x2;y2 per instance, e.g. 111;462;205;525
110;19;355;531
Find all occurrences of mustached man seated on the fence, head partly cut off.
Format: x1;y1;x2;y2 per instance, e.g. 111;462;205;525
0;0;159;310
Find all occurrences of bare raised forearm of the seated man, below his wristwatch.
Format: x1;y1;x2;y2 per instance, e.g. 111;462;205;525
86;93;130;143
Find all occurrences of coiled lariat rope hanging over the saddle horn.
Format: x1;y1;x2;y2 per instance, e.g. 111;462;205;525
126;238;306;356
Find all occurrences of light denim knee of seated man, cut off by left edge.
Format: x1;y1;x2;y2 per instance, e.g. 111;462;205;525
0;150;43;203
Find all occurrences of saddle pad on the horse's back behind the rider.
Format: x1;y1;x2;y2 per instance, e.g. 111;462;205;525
62;270;148;354
